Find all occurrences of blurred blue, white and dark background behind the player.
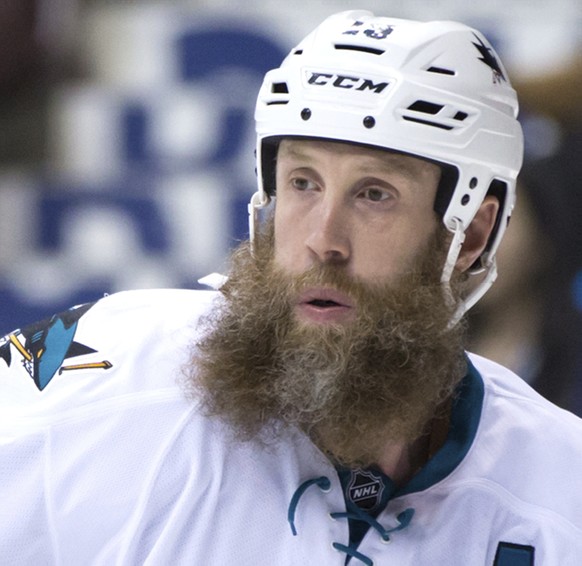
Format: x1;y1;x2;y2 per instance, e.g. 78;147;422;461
0;0;582;414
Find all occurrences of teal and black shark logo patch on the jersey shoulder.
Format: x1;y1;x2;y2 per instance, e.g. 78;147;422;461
0;303;112;391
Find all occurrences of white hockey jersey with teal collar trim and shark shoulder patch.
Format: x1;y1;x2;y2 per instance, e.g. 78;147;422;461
0;290;582;566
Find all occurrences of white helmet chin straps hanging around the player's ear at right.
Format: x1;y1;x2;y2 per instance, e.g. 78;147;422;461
441;218;497;328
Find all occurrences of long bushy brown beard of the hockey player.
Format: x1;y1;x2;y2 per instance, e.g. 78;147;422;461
190;224;466;466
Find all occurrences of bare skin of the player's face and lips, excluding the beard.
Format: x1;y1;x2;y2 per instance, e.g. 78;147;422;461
274;140;440;323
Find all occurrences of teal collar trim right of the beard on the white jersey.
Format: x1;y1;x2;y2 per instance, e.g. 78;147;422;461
393;358;485;497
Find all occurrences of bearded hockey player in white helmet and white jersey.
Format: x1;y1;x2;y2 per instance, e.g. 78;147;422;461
0;12;582;566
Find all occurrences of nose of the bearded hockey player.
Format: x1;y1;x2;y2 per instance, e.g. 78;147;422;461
305;197;351;263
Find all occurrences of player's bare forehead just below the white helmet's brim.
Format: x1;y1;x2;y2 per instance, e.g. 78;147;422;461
277;139;440;181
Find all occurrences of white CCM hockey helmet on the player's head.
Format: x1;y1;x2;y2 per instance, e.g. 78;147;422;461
249;11;523;318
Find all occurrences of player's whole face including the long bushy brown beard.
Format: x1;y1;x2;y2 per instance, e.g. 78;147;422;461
191;141;465;465
